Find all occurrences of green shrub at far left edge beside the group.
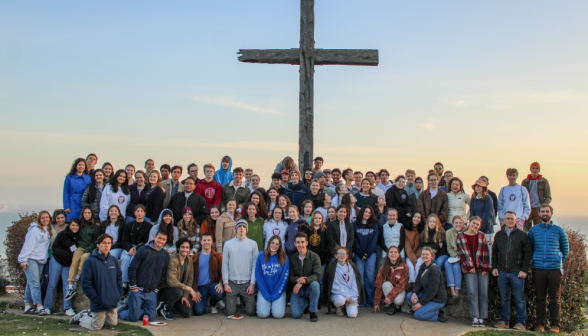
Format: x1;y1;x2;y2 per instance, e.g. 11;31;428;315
4;212;37;295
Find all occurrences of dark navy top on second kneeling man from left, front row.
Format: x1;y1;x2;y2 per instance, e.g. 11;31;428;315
129;241;169;293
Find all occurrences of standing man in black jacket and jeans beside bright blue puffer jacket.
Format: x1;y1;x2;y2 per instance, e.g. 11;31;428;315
491;211;532;330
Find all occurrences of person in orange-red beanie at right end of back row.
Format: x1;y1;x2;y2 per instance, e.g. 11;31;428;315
522;162;551;230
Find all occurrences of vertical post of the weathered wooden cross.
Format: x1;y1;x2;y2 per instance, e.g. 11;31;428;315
298;0;314;170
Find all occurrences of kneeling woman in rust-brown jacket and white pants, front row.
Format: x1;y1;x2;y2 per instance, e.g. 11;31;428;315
372;246;409;315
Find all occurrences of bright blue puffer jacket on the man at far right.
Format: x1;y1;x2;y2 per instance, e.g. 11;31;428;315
529;222;570;270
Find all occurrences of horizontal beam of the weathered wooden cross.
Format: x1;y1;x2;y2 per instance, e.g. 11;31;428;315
237;49;379;66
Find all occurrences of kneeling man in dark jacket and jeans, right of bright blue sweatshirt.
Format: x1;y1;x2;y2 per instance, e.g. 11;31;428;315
289;232;323;322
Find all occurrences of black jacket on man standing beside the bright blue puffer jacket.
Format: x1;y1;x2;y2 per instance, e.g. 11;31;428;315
492;227;533;273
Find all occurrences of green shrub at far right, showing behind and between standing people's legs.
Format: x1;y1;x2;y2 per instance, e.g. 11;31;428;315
488;227;588;332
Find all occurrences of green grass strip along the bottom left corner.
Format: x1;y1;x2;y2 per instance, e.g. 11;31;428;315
0;314;151;336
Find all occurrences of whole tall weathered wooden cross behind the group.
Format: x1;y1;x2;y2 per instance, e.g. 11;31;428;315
238;0;378;171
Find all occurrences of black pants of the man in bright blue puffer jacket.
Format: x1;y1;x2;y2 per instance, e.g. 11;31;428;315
533;268;563;327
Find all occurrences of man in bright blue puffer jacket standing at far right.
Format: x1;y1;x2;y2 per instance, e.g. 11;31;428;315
529;204;569;333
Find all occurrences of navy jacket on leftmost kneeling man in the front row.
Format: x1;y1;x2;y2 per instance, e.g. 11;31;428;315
81;248;123;312
